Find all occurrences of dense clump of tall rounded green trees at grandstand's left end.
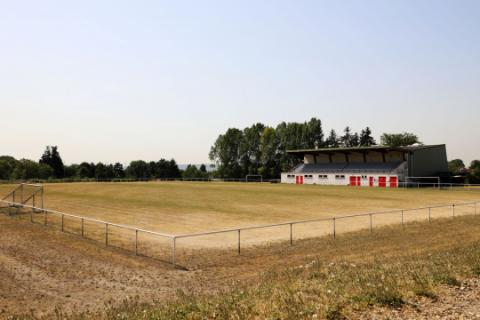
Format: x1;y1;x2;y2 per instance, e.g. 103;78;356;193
209;118;326;178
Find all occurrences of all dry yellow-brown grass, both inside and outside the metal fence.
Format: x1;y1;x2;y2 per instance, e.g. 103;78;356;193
0;182;480;319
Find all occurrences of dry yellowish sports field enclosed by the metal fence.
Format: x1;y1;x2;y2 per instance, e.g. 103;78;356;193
0;182;480;251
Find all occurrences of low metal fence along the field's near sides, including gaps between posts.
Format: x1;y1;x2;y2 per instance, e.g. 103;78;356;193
0;200;480;267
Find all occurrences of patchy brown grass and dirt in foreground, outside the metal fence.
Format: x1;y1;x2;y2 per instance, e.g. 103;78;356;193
0;209;480;319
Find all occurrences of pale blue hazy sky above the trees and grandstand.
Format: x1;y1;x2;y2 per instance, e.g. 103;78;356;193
0;0;480;163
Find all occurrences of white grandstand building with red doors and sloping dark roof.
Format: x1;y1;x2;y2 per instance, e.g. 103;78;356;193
281;145;448;188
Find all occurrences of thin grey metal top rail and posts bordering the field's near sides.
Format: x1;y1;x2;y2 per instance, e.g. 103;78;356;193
0;200;480;267
